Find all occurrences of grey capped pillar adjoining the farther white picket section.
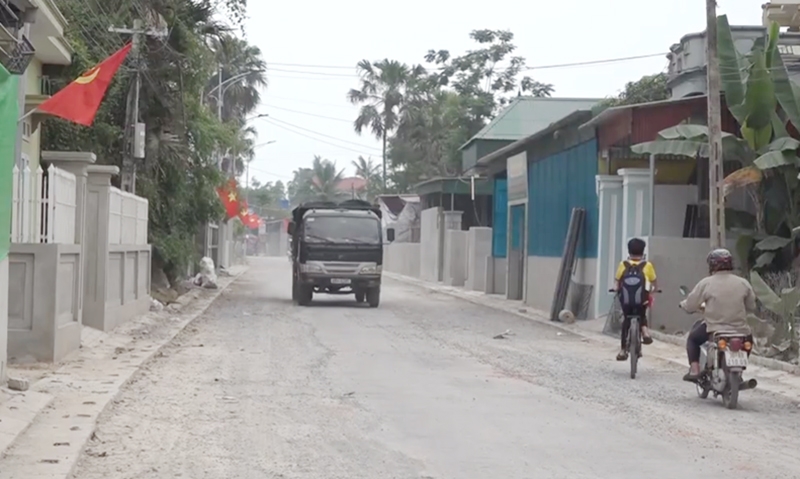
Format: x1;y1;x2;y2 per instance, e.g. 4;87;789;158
83;165;119;331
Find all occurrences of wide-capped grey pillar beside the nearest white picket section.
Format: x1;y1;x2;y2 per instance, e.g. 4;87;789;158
42;151;97;322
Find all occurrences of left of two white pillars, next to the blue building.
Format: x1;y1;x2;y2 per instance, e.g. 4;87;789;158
594;175;623;317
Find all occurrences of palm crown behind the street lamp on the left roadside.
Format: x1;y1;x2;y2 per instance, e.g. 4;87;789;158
207;34;268;121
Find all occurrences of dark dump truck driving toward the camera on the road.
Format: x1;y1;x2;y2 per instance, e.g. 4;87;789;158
289;200;394;308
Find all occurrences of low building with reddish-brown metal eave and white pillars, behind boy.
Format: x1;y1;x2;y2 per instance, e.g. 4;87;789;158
580;96;748;332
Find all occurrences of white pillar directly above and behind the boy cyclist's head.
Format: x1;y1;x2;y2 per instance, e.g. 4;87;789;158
617;168;650;258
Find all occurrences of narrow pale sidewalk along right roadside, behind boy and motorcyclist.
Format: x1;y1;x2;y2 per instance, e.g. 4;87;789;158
386;272;800;404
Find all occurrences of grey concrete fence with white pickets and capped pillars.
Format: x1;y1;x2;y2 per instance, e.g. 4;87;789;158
5;155;151;368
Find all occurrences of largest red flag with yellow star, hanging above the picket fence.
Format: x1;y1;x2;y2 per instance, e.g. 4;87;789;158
38;43;131;126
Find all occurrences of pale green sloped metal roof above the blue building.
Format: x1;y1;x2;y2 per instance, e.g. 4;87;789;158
460;96;601;149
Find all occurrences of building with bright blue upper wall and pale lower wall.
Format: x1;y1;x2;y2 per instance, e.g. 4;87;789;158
468;105;598;315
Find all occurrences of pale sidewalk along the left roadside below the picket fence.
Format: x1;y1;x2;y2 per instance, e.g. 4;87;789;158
0;266;247;479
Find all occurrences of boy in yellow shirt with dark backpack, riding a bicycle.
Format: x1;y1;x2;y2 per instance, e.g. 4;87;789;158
614;238;657;361
